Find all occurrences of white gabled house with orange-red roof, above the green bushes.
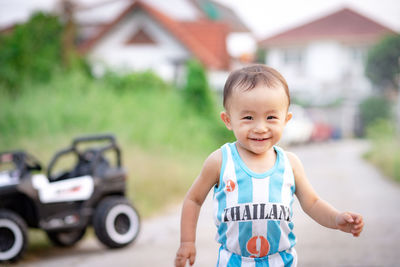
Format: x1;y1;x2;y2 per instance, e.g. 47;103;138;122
76;0;255;88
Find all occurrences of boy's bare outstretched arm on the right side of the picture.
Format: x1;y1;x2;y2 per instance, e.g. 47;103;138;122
287;153;364;236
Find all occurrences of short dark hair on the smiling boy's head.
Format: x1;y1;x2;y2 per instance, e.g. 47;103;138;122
224;64;290;109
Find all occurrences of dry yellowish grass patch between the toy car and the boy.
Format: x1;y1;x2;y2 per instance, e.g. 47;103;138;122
125;146;204;217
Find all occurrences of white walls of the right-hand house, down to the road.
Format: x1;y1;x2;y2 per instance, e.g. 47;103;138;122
266;40;372;136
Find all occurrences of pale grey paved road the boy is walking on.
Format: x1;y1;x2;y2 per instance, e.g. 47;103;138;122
18;141;400;267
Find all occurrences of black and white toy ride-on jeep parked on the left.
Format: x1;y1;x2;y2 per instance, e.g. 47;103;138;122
0;135;140;262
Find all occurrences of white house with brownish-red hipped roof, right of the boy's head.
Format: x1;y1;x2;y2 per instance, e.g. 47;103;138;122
259;8;394;136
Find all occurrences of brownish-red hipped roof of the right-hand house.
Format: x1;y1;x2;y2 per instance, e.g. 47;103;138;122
260;8;394;46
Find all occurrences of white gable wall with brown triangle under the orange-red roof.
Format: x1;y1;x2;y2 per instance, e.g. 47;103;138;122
89;10;190;80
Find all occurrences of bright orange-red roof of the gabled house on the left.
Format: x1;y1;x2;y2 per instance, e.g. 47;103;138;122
79;1;229;69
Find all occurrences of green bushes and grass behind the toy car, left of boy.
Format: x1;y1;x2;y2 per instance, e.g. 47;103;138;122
0;11;232;220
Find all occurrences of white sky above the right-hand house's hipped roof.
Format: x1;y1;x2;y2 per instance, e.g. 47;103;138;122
214;0;400;38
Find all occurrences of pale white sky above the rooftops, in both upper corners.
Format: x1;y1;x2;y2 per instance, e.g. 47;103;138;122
0;0;400;39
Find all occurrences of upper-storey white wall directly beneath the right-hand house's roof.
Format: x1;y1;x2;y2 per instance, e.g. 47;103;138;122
266;40;372;102
